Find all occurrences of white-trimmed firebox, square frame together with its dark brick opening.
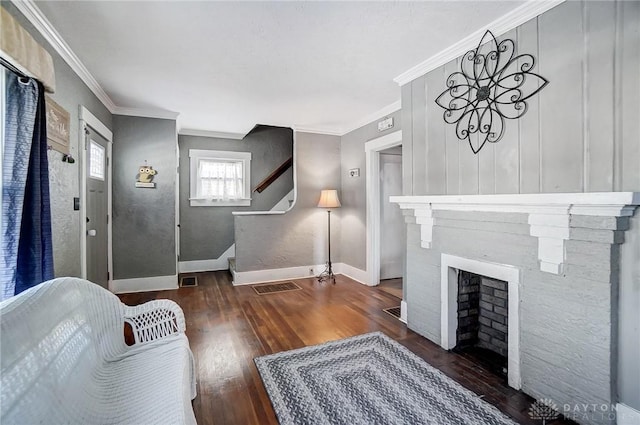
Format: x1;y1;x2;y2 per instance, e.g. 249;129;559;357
440;254;521;389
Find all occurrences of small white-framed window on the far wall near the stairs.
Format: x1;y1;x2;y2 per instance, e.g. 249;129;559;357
189;149;251;207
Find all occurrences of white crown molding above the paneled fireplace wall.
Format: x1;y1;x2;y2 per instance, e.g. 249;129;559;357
393;0;565;86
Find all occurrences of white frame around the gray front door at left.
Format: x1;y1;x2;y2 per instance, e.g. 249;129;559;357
78;105;113;291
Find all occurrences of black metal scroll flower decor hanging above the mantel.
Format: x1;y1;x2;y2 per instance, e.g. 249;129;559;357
436;31;549;154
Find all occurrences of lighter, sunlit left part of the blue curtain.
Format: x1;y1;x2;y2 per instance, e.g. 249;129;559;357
0;68;38;299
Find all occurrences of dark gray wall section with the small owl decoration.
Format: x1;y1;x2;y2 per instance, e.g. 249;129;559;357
113;115;177;279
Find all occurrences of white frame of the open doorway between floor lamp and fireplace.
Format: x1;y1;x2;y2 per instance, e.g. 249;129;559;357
364;130;402;286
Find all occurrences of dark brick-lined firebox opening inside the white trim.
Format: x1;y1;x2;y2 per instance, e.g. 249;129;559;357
453;270;509;379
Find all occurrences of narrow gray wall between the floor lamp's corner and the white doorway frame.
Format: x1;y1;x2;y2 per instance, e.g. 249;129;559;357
340;111;402;270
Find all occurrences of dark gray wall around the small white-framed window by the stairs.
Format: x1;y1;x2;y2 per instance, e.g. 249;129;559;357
178;126;293;261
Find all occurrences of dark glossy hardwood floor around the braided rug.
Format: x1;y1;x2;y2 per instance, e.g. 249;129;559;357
120;272;570;425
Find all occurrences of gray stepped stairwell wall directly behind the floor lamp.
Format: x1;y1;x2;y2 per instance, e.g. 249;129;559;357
235;133;345;272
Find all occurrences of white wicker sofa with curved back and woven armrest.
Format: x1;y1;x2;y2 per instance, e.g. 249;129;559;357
0;278;196;425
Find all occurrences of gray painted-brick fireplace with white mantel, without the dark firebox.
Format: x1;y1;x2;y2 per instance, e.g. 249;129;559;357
391;192;640;424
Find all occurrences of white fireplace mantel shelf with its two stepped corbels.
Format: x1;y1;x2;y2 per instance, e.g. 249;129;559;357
390;192;640;274
